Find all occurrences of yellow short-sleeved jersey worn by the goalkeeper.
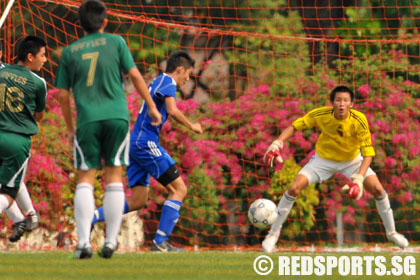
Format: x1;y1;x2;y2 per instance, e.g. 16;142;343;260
292;107;375;161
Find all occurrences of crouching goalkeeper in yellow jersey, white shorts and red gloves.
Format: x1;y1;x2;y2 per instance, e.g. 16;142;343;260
262;86;408;252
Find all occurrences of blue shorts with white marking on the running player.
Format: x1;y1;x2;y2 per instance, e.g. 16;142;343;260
127;141;175;188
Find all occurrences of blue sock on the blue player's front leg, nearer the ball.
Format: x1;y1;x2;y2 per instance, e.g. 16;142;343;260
155;199;182;244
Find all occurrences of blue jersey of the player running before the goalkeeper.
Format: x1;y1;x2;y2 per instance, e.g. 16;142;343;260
130;73;176;145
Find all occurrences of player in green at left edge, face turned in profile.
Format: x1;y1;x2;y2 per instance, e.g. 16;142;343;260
0;36;47;241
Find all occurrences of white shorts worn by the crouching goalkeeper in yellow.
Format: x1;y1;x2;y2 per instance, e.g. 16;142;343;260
298;153;376;185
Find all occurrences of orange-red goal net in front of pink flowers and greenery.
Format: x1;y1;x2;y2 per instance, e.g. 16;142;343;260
0;0;420;249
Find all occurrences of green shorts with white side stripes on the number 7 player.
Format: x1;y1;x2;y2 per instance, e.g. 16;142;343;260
74;119;130;170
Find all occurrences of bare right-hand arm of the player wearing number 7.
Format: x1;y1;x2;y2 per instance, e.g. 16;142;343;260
128;67;162;125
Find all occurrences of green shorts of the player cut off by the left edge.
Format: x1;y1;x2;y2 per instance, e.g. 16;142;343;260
0;131;31;198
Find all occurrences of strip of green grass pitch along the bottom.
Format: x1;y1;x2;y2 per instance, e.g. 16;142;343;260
0;251;420;280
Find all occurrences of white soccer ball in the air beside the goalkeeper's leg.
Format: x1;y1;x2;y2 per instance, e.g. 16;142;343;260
248;198;278;229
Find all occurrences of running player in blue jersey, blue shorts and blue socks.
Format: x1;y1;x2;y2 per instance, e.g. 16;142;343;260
92;51;202;252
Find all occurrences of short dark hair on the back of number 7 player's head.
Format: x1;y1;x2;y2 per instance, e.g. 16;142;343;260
79;0;106;33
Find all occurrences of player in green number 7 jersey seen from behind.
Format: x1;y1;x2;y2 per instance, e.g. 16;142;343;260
56;0;161;259
